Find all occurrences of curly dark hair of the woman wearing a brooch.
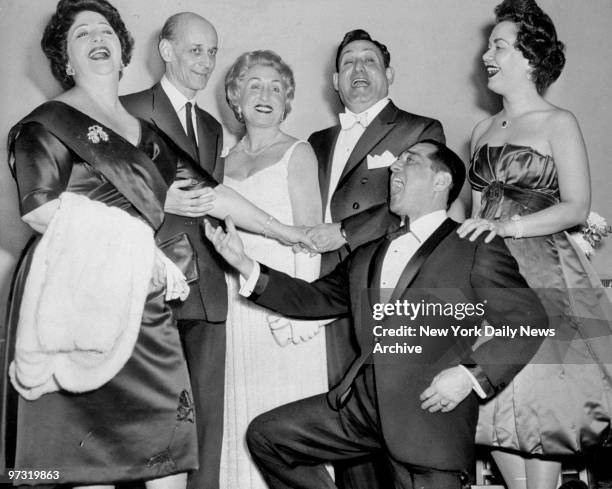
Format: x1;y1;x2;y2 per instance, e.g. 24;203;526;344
40;0;134;90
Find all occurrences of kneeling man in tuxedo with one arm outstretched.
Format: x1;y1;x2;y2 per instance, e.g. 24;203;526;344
206;140;547;489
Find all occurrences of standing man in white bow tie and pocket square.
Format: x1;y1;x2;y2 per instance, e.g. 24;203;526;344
309;29;444;489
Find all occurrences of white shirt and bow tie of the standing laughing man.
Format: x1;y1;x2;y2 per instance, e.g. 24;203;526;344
325;97;389;222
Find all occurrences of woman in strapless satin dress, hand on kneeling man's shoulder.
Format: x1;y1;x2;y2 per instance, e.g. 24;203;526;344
458;0;612;489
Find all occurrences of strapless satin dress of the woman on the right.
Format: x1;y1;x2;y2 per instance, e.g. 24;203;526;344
468;144;612;455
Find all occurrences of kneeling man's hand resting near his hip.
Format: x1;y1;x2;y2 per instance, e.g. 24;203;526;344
420;367;473;413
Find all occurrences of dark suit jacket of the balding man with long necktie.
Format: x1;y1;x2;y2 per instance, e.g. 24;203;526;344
121;83;227;322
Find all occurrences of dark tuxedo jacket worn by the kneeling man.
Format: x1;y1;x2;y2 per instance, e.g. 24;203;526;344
251;219;548;470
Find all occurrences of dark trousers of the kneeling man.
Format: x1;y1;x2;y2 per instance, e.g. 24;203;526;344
247;365;462;489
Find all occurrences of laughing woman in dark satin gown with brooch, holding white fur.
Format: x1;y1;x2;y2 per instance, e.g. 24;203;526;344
0;0;310;489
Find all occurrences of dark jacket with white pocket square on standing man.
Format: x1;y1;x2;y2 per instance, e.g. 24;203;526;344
308;101;445;273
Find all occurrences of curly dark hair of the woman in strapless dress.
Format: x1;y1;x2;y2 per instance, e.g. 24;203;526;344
495;0;565;93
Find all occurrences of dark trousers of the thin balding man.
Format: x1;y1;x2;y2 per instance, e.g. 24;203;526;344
178;319;225;489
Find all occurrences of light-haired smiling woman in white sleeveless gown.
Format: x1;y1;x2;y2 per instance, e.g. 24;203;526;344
221;51;327;489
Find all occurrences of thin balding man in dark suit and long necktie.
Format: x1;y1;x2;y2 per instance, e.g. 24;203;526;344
121;12;227;489
